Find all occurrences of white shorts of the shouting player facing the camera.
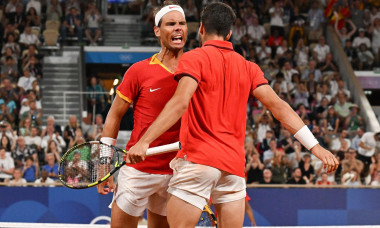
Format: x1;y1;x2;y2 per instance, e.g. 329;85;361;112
110;166;172;217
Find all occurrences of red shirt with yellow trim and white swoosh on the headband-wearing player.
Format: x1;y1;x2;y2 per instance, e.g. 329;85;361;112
117;55;180;174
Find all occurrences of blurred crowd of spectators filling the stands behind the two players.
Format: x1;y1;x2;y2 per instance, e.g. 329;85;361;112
0;0;380;186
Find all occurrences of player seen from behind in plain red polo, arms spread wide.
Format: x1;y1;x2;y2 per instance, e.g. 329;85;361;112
127;2;338;228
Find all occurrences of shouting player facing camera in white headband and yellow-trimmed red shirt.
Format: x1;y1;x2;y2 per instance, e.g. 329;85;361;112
98;1;187;228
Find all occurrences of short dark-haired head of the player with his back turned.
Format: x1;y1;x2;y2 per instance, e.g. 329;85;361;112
201;2;236;37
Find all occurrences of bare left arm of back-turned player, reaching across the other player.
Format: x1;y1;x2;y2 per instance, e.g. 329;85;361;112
128;76;198;162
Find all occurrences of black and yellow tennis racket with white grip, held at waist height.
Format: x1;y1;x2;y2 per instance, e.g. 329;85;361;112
58;141;181;189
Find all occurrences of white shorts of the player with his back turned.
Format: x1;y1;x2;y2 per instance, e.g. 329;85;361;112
168;158;246;210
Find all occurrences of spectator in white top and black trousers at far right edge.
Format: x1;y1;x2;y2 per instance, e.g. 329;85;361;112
358;132;380;181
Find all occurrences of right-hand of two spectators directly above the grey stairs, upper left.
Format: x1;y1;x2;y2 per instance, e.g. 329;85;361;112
84;2;103;46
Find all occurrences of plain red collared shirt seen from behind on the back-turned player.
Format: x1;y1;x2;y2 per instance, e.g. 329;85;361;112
175;40;268;177
